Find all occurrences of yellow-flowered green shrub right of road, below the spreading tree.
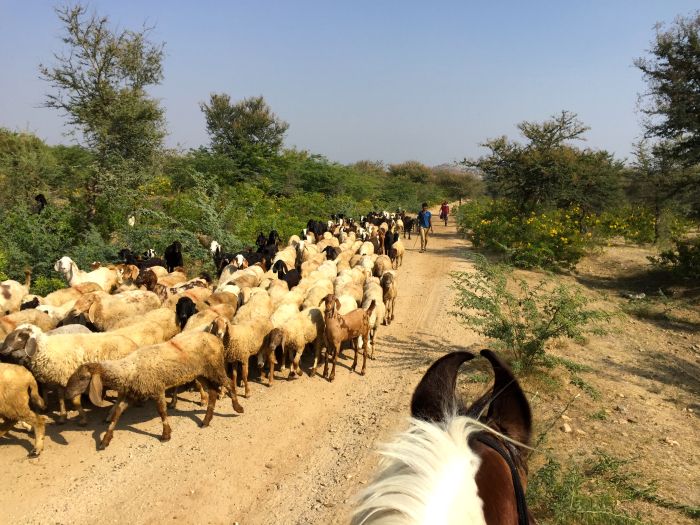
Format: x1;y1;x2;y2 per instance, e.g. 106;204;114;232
458;200;591;269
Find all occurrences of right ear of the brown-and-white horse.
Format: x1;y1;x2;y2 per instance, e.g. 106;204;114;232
481;350;532;445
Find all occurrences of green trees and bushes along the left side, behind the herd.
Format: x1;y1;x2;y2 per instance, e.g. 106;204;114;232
0;5;481;294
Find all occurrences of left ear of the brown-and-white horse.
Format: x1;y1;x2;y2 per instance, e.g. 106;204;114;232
411;352;475;421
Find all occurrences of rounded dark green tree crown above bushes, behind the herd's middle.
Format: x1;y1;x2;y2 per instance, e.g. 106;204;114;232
200;93;289;172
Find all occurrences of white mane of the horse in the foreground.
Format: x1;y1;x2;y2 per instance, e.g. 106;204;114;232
351;416;486;525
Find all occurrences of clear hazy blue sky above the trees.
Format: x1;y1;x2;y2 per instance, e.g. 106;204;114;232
0;0;698;165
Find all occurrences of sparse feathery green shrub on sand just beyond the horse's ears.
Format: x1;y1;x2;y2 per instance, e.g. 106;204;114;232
452;255;610;371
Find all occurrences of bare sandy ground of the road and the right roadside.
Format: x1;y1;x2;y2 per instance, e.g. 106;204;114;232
0;211;700;525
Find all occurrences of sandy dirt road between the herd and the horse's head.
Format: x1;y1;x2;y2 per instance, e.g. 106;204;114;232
0;210;476;525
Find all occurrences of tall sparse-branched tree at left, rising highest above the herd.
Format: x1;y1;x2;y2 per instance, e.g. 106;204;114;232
39;5;165;222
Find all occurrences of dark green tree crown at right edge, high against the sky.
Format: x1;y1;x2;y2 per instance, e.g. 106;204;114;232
634;11;700;165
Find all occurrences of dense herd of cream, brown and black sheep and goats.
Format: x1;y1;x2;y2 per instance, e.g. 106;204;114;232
0;212;415;457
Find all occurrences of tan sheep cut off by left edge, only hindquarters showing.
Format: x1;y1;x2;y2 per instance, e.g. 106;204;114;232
0;363;45;457
